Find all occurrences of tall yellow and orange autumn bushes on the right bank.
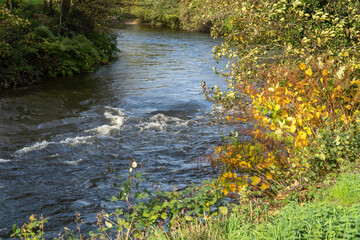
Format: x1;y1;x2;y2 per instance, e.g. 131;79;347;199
198;0;360;198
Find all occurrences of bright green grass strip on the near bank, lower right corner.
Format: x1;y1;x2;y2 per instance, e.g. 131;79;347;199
150;174;360;240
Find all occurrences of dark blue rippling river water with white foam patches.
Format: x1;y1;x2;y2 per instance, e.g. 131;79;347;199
0;26;229;238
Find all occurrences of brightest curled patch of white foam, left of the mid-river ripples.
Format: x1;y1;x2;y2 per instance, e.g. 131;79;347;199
87;107;125;136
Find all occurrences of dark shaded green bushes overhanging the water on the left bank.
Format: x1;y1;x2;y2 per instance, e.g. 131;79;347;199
0;1;117;88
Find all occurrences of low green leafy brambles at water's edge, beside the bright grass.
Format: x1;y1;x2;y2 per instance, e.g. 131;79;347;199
93;161;228;239
